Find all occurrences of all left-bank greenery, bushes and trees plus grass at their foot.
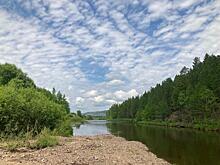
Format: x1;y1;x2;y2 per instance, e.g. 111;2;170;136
0;64;84;151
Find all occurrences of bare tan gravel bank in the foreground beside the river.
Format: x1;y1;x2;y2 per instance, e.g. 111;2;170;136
0;135;169;165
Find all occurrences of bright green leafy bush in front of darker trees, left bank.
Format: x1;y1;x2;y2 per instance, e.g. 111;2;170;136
0;87;67;135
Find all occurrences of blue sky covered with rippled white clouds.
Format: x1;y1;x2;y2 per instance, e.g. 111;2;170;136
0;0;220;112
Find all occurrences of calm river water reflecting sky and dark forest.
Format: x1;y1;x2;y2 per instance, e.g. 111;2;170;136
74;121;220;165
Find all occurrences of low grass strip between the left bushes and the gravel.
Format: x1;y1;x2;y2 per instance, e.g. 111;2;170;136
0;116;85;152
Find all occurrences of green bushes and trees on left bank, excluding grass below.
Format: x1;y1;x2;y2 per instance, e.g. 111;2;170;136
0;64;72;137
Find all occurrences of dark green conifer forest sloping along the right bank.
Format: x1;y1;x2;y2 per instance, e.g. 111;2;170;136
107;54;220;130
